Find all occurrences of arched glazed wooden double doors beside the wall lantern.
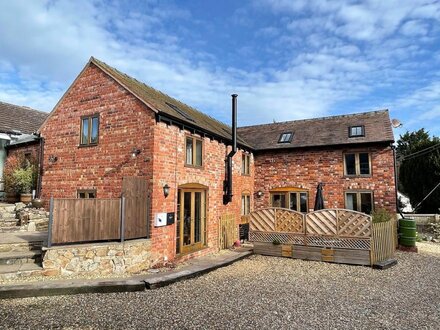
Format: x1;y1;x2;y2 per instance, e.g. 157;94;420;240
176;189;206;254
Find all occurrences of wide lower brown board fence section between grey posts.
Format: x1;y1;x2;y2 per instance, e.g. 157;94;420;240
52;199;121;244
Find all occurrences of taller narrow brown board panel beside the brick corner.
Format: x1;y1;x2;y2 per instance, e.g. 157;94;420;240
122;177;149;239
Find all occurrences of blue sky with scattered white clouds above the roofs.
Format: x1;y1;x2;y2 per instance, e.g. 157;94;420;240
0;0;440;136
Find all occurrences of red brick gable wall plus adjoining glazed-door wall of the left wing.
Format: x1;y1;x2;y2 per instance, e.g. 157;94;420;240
41;65;254;263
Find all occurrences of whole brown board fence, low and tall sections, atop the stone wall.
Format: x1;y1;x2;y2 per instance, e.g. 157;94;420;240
48;177;150;246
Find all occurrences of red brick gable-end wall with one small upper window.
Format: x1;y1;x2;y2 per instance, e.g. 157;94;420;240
41;64;155;200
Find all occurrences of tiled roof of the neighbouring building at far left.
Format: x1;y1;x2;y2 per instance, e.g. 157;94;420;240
0;102;49;134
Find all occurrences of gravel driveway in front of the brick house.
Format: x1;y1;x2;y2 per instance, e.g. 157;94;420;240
0;243;440;329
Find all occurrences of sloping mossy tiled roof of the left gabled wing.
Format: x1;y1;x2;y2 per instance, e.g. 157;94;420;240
90;57;250;147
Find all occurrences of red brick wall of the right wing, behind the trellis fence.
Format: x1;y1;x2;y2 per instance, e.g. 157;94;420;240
255;146;396;213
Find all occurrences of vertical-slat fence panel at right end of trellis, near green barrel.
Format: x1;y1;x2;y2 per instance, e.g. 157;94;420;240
371;221;396;264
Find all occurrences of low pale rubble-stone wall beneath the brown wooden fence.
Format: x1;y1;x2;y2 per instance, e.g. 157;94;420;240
43;239;154;276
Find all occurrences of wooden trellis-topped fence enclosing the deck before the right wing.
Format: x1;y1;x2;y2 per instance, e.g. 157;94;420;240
249;208;395;264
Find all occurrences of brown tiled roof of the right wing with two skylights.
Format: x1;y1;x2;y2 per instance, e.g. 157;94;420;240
238;110;394;150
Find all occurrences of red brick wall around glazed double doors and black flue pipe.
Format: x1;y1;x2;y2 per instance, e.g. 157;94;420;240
152;123;254;259
